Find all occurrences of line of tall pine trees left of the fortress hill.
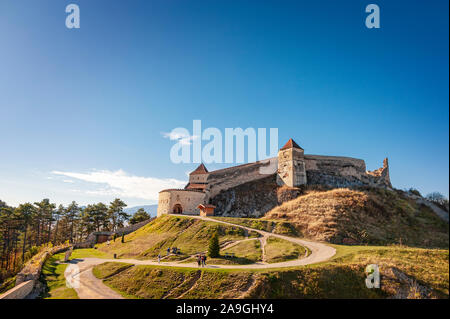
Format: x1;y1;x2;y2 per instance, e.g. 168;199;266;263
0;198;150;283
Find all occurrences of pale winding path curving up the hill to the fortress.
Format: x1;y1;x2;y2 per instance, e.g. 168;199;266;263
64;215;336;299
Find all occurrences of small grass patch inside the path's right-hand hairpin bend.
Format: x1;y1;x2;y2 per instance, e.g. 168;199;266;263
265;237;306;263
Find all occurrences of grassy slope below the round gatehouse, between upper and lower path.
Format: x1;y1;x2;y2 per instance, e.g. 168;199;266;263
98;215;258;260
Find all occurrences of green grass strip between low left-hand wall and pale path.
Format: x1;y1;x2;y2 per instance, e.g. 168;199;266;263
40;253;78;299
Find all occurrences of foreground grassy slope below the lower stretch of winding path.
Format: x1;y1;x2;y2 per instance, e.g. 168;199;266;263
94;246;449;299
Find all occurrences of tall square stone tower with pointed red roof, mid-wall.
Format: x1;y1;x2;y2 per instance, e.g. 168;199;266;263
277;138;306;187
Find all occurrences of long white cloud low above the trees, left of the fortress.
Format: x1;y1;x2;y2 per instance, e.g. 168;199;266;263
52;169;186;201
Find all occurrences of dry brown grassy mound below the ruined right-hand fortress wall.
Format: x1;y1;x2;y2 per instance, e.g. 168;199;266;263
263;189;449;248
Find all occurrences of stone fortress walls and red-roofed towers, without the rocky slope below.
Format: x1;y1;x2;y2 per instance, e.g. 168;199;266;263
157;139;392;216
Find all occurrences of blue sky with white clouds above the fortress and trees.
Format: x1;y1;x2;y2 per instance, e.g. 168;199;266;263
0;0;449;206
